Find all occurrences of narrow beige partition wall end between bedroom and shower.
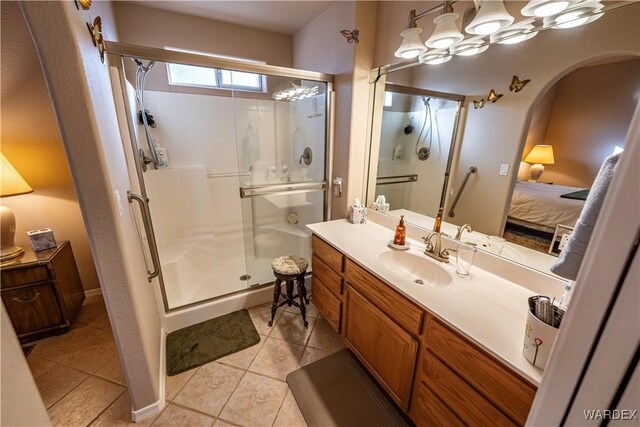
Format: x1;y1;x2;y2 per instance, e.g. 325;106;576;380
21;1;164;415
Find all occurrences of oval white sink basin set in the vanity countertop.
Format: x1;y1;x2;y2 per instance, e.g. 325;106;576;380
378;251;451;286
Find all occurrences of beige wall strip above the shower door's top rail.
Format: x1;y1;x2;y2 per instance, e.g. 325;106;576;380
113;1;293;67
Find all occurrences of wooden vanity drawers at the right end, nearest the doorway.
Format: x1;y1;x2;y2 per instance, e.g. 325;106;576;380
410;316;536;426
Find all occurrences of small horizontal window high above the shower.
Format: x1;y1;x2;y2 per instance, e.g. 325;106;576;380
167;63;266;93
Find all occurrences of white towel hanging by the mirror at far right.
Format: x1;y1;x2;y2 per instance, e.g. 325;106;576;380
551;153;620;280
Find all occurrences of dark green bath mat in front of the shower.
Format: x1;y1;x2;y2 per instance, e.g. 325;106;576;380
167;310;260;376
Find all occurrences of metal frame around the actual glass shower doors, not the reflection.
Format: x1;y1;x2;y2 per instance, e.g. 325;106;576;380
104;41;335;314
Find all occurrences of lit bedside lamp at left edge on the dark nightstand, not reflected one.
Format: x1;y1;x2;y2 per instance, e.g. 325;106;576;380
0;153;33;263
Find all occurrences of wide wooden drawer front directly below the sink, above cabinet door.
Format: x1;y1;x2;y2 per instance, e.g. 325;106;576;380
345;258;424;336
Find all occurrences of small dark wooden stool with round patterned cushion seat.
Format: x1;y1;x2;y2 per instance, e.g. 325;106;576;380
269;255;309;328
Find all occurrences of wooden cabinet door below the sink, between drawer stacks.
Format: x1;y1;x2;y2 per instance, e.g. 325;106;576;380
344;287;418;411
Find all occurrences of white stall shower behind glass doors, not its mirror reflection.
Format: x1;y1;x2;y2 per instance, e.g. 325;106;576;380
111;48;331;313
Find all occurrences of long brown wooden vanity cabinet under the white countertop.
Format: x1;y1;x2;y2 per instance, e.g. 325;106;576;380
312;235;536;427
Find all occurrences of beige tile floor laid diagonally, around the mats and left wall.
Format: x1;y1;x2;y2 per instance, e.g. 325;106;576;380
27;296;342;427
